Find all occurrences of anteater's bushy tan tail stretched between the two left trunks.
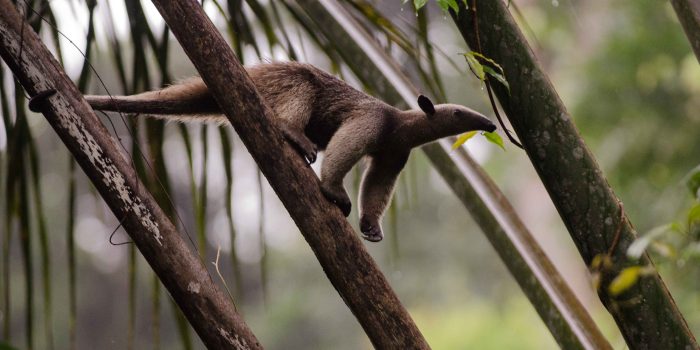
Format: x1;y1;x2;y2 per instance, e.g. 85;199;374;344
85;78;226;122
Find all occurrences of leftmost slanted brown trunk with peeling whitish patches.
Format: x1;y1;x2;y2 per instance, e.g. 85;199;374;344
0;0;261;349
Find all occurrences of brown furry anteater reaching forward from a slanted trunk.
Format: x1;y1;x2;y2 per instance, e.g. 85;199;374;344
86;62;496;241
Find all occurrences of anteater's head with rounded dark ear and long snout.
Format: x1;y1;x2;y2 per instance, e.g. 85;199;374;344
418;95;496;135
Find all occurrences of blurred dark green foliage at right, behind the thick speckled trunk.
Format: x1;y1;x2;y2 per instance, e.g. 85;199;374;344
573;1;700;232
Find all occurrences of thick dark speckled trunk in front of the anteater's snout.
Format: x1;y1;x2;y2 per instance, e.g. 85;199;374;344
452;0;698;349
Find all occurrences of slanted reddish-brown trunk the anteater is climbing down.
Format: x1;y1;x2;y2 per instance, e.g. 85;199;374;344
153;0;428;349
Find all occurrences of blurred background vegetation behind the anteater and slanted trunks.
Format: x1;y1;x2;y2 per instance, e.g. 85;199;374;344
0;0;700;349
